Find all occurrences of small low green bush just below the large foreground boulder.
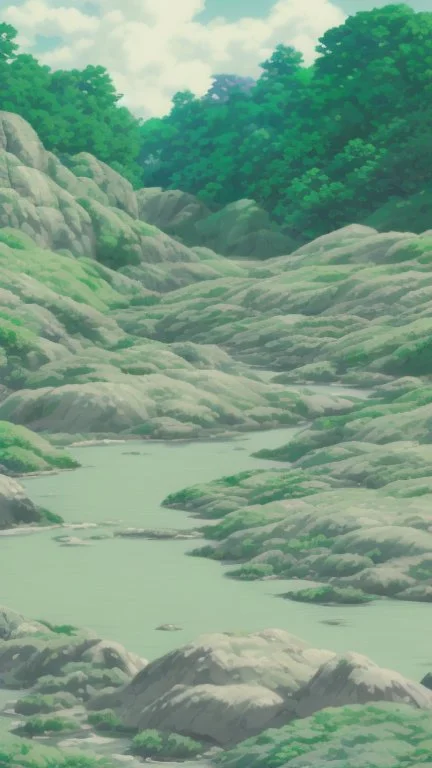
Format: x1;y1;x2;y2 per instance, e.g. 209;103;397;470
131;730;204;760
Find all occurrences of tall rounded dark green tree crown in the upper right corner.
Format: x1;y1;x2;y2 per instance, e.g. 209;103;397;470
315;5;432;143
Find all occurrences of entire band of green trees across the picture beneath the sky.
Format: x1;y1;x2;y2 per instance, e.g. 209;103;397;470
0;5;432;240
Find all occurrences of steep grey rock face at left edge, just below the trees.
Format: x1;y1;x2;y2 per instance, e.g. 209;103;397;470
0;112;223;287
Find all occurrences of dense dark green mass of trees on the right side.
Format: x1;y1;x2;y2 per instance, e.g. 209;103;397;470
142;5;432;239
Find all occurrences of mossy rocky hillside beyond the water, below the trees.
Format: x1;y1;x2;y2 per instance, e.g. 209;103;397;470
0;113;432;602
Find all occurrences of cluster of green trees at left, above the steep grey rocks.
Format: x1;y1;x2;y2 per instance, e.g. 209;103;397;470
0;24;142;186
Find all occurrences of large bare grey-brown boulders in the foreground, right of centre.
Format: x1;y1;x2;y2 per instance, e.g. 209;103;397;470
89;630;432;746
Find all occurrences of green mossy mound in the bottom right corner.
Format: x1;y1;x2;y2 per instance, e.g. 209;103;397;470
215;703;432;768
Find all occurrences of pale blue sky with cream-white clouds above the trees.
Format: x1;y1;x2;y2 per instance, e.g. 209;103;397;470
0;0;432;118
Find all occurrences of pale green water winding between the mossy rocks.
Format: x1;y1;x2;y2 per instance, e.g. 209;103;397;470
0;414;432;680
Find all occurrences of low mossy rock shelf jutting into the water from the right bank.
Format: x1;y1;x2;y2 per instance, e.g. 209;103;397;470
166;476;432;603
